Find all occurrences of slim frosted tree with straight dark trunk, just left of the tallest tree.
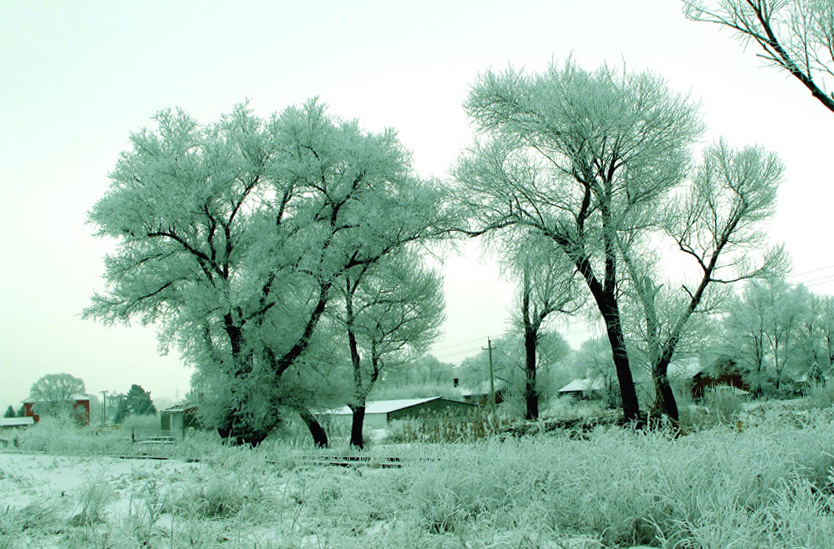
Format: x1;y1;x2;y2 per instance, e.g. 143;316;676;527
502;233;584;420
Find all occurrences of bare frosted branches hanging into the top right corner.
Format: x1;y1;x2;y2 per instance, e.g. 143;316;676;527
683;0;834;112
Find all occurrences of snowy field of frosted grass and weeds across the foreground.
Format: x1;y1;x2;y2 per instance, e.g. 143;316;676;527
0;407;834;549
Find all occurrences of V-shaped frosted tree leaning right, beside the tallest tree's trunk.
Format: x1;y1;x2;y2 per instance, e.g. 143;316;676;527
621;141;786;422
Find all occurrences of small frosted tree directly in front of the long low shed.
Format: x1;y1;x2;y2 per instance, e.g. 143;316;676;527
336;251;444;448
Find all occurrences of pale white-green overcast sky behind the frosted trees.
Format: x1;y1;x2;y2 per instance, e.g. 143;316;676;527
0;0;834;409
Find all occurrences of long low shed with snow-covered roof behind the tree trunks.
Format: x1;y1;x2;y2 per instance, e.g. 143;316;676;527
322;397;477;429
